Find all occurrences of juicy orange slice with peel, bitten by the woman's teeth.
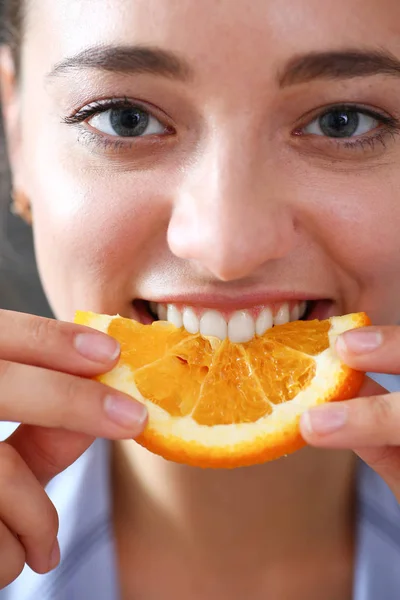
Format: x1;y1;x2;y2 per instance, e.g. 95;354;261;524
75;312;369;468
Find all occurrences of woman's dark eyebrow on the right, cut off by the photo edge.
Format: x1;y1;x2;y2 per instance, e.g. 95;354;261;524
279;50;400;87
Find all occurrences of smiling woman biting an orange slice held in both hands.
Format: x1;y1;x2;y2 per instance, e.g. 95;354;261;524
0;0;400;600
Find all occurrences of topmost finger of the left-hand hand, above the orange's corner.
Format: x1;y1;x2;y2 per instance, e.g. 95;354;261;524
0;310;120;377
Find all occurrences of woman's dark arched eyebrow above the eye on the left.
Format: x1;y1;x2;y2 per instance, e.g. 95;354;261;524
48;46;193;80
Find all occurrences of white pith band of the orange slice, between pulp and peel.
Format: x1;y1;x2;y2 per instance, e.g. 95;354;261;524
90;315;358;450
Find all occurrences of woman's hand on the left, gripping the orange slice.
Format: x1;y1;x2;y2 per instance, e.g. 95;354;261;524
0;311;146;589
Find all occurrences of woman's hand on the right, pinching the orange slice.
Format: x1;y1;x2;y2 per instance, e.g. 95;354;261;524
301;326;400;502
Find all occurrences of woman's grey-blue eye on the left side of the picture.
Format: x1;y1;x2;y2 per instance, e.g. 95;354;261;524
87;106;166;137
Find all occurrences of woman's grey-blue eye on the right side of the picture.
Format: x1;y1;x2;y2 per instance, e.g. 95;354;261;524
303;108;381;138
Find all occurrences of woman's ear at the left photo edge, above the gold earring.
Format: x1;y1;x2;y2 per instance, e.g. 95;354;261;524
0;46;23;188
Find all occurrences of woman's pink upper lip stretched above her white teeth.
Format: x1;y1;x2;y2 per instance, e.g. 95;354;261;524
139;290;327;309
